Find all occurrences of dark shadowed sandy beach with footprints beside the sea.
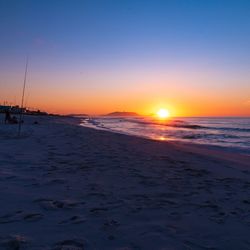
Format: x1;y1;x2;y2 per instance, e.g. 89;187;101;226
0;116;250;250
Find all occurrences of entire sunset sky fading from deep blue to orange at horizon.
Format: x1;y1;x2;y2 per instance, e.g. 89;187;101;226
0;0;250;116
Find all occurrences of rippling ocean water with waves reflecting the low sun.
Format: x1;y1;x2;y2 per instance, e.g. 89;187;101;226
82;116;250;154
